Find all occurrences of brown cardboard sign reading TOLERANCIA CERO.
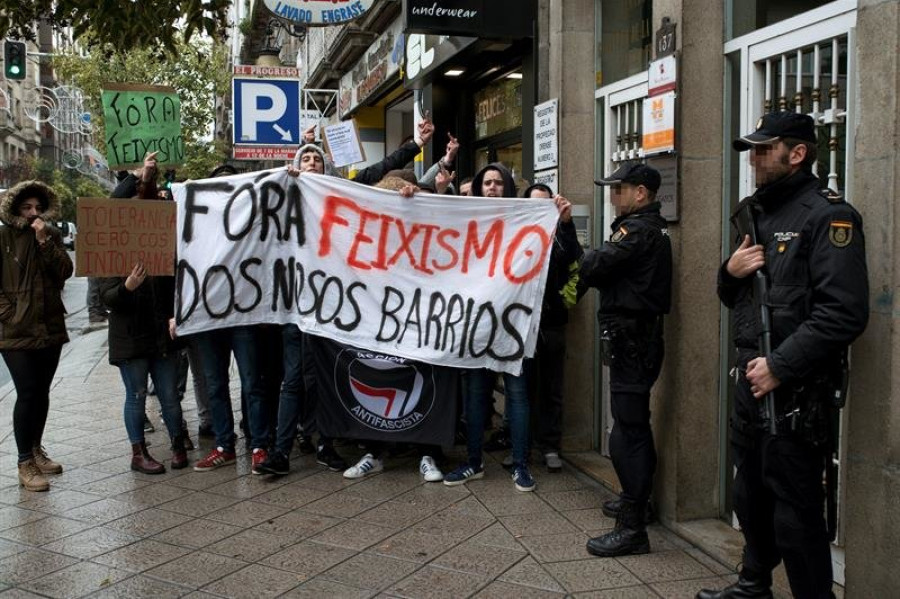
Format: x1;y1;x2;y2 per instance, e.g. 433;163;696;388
75;198;176;277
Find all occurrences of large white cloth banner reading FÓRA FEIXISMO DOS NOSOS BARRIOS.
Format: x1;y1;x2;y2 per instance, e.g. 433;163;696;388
173;169;557;374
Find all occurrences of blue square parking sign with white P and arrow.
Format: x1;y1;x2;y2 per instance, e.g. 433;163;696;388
231;77;301;146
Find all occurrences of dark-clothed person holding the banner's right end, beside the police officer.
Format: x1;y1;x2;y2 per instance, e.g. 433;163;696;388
522;183;584;472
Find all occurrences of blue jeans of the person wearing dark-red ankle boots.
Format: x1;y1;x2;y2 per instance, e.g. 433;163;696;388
117;353;181;443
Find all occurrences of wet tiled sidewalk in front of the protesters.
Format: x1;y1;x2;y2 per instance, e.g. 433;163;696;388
0;330;734;599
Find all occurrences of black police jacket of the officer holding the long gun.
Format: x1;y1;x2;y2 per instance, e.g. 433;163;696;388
718;171;869;383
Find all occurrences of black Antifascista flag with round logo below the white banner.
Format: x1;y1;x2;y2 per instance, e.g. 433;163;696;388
306;334;459;445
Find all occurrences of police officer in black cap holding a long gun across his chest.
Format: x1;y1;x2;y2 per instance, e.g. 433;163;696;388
697;112;869;599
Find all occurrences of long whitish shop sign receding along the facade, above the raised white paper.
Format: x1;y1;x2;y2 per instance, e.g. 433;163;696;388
338;19;403;118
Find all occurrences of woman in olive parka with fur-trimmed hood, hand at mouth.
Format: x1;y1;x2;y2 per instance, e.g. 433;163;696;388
0;180;73;491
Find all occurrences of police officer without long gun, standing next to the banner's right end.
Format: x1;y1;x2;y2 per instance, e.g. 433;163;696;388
579;162;672;557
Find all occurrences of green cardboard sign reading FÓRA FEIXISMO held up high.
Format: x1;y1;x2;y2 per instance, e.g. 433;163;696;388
101;83;184;170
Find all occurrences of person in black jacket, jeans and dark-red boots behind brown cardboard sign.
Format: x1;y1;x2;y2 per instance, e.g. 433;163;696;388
100;152;188;474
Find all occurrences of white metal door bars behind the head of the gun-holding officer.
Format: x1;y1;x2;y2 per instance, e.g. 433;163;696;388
757;35;849;192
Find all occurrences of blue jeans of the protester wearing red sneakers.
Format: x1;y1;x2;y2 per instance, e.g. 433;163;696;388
195;326;269;452
